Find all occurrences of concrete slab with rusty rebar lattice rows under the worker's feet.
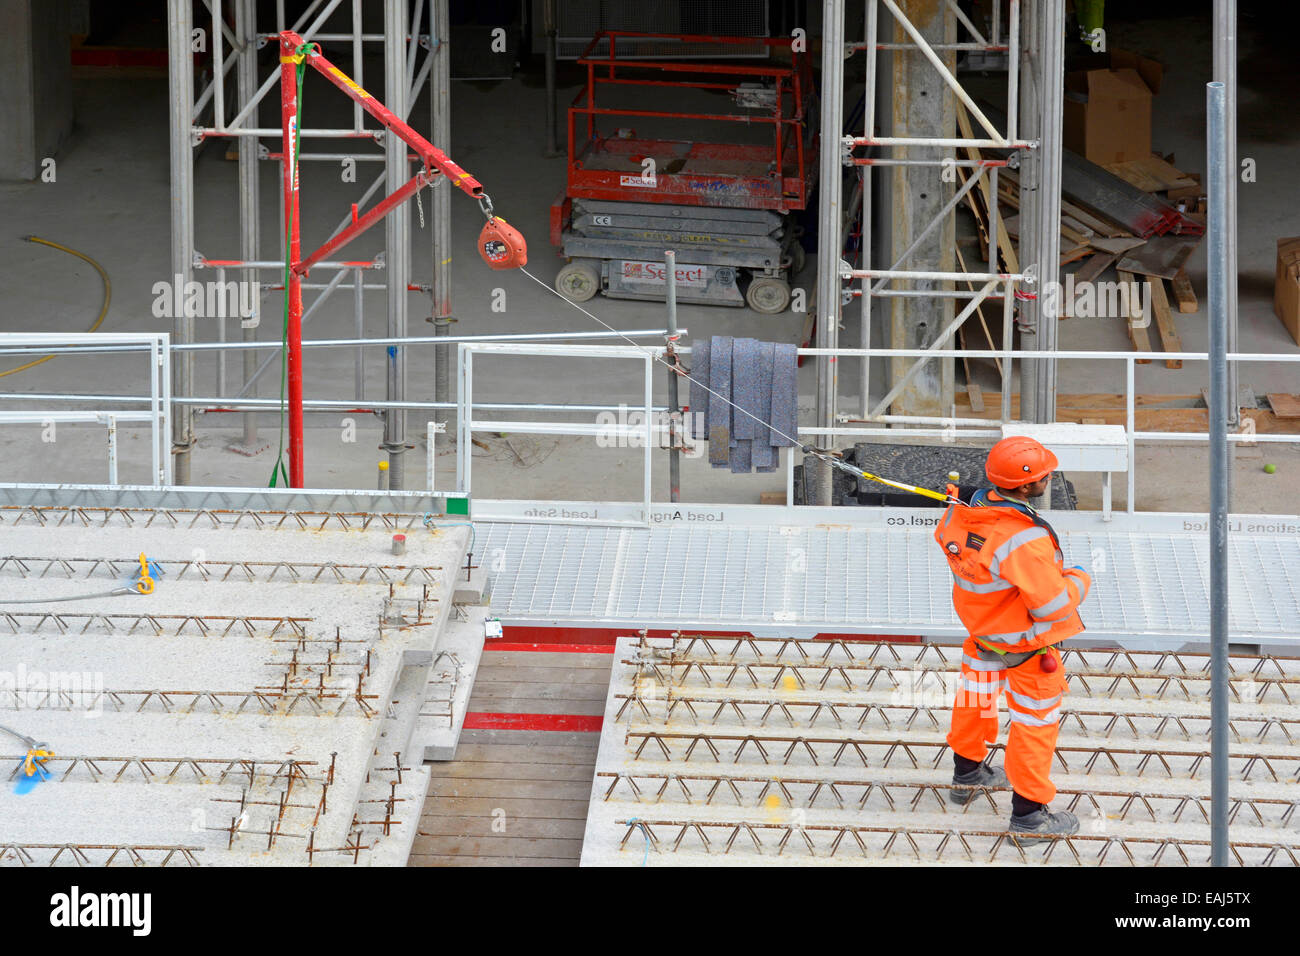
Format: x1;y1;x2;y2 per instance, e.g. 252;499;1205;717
593;633;1300;866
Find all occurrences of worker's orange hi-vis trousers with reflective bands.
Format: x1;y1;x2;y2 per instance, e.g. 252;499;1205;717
948;637;1067;804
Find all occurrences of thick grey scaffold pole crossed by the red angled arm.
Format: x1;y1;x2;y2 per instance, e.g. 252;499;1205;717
384;0;411;490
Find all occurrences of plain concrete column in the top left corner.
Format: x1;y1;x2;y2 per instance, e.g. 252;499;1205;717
0;0;73;182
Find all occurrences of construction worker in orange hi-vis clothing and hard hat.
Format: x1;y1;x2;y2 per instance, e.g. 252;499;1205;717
935;436;1091;844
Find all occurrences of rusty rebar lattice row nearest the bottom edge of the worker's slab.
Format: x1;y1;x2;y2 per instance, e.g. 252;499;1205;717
616;817;1300;866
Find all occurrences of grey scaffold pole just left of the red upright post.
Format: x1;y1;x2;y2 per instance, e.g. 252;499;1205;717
235;0;261;451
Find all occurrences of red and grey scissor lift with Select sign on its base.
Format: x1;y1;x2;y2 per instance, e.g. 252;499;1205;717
550;31;816;313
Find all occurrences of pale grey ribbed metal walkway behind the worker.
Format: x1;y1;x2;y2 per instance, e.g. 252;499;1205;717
478;520;1300;641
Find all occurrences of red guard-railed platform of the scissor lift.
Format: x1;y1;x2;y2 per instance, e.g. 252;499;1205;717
566;31;816;214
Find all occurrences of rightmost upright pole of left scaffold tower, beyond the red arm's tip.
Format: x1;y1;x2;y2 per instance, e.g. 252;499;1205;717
429;0;452;433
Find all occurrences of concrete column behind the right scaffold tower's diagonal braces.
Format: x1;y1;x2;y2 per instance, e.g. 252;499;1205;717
880;0;957;415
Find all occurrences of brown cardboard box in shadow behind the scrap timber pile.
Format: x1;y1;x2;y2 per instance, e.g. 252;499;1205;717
1063;49;1164;165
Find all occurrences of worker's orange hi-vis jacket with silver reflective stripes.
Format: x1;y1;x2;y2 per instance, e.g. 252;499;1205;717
935;485;1091;654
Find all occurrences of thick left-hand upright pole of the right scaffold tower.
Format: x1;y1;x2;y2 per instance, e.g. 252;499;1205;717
805;0;844;505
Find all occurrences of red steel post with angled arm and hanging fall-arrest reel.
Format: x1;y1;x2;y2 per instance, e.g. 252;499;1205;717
277;30;528;488
